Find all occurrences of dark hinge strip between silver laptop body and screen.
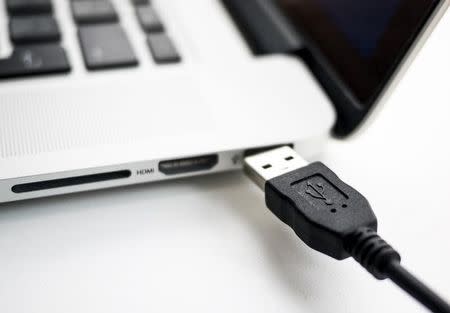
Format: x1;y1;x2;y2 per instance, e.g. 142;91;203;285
222;0;364;137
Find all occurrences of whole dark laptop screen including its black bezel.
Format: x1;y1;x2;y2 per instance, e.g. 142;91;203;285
276;0;439;105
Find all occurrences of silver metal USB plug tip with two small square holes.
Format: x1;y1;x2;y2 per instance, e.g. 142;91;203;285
244;146;309;190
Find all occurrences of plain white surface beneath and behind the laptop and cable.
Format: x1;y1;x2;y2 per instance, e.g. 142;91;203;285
0;8;450;313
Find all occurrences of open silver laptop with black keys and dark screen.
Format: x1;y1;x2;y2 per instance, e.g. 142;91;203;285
0;0;449;202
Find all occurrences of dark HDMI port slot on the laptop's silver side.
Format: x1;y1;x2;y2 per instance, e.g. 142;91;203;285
158;154;219;175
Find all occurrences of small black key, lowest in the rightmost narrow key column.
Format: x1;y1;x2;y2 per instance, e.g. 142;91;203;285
147;33;181;64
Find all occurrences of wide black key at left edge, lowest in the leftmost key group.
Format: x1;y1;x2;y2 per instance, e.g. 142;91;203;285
0;44;70;79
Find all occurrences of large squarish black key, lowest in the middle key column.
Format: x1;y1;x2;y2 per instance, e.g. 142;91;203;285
78;24;138;70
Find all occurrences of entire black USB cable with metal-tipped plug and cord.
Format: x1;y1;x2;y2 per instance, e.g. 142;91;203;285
244;147;450;313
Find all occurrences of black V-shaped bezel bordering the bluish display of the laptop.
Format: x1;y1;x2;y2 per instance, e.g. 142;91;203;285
276;0;440;108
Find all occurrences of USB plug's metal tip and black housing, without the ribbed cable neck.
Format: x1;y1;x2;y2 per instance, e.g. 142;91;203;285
245;147;377;260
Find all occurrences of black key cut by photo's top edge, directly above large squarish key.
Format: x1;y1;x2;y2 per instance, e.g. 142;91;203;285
71;0;119;24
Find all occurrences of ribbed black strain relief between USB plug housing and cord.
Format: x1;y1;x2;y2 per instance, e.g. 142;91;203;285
346;227;401;280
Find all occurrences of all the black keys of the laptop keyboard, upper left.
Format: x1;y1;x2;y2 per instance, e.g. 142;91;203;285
0;0;181;79
